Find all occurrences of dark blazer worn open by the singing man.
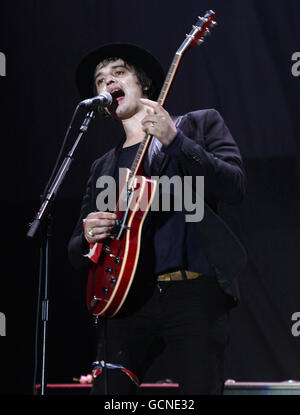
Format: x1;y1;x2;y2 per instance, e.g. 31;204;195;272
68;109;247;298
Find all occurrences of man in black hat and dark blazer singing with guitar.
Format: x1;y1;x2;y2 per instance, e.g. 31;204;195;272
69;44;246;394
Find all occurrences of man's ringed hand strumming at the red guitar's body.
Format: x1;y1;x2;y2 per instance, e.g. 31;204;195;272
83;212;117;244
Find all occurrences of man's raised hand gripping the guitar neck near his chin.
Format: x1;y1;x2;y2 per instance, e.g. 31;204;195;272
140;98;177;146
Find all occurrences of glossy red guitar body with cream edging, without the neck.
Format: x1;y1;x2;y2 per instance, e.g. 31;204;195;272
86;169;156;317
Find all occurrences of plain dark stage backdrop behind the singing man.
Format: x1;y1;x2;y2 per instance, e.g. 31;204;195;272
0;0;300;394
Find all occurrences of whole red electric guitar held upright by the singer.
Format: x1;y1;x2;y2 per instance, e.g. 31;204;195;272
87;10;216;317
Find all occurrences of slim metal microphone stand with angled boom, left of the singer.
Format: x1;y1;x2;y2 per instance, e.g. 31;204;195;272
27;104;95;395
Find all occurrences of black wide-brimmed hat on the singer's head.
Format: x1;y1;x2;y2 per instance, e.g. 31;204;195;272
76;43;165;99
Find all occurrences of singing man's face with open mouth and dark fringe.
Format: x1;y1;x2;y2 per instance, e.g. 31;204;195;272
94;59;145;121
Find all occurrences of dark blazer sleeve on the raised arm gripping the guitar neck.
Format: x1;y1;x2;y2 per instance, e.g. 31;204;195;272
163;109;245;204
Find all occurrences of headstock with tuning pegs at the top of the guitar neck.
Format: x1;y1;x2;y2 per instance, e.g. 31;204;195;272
178;10;217;54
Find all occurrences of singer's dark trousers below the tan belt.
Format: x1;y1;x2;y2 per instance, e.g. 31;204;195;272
91;276;229;395
